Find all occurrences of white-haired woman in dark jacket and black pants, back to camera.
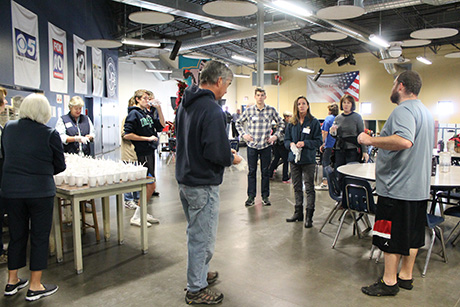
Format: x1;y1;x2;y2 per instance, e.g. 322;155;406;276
1;94;66;301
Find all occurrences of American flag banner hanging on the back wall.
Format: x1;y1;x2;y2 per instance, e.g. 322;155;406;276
307;71;359;102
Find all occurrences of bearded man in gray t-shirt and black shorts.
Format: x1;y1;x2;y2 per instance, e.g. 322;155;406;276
358;71;434;296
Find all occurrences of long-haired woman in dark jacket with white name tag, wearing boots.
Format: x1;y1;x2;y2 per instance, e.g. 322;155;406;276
284;96;322;228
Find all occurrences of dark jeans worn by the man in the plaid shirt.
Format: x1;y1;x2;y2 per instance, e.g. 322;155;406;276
248;146;272;197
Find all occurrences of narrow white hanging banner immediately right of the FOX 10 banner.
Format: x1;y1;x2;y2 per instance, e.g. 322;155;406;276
73;34;88;95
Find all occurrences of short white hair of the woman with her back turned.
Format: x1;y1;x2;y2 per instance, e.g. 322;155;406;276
19;94;51;124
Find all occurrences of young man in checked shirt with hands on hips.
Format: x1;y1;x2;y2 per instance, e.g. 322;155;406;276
236;88;285;207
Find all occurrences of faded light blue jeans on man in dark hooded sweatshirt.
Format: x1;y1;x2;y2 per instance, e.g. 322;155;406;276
179;184;219;292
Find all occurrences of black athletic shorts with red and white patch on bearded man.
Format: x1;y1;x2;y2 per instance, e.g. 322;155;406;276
372;196;427;256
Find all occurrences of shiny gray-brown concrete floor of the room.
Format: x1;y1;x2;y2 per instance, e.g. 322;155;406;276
0;148;460;307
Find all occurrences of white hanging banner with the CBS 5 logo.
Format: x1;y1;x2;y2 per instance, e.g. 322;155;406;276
11;1;40;88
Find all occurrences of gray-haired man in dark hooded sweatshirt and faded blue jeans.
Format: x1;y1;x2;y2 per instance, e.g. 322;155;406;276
176;61;241;304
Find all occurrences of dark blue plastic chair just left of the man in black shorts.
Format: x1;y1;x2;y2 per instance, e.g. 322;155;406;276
332;176;376;248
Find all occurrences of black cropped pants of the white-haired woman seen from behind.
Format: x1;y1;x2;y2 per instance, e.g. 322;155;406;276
4;196;54;271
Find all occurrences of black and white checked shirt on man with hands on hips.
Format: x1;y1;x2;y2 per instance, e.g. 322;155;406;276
236;105;285;149
